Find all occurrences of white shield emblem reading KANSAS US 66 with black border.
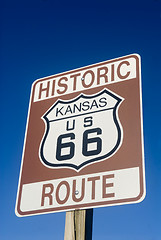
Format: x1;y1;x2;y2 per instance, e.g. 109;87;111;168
40;89;123;171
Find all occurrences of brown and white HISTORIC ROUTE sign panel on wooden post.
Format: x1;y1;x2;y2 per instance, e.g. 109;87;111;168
16;54;145;216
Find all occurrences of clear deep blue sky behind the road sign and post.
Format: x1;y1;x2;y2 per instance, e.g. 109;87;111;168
0;0;161;240
